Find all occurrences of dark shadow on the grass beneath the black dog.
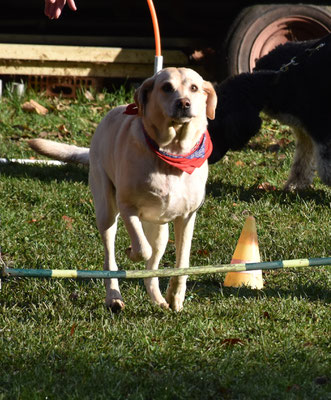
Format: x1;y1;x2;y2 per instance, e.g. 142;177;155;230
206;181;330;206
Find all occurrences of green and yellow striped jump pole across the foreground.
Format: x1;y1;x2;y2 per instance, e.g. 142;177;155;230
1;257;331;279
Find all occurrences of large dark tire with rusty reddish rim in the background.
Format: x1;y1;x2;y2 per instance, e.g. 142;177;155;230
225;4;331;75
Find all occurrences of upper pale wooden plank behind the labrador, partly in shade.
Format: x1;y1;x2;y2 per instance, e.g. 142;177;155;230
0;43;188;65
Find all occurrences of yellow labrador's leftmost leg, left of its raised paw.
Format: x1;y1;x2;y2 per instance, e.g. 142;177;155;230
89;166;124;312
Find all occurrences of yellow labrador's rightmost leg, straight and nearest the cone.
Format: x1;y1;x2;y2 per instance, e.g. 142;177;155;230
166;212;196;311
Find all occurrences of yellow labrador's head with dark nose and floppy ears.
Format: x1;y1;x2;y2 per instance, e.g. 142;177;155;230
135;68;217;148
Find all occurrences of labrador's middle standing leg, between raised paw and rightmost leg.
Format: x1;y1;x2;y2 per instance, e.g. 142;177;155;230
143;222;169;308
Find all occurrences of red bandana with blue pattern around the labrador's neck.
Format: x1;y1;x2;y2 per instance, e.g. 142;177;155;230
124;104;213;174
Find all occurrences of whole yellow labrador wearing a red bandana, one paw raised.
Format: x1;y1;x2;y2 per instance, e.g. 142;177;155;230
29;68;217;311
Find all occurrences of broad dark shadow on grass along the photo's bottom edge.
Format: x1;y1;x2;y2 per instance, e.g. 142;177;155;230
0;332;329;400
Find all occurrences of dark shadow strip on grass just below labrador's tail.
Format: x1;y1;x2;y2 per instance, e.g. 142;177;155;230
0;163;88;184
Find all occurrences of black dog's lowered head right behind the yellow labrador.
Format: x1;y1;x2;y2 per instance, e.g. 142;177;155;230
208;71;276;164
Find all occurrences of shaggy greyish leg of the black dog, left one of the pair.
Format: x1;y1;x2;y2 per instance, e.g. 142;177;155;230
284;128;315;190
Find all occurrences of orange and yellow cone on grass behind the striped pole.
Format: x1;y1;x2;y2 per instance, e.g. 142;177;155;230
224;216;263;289
